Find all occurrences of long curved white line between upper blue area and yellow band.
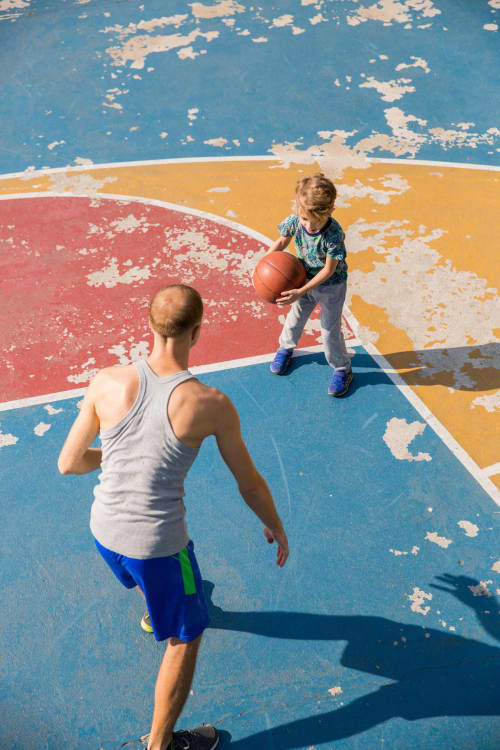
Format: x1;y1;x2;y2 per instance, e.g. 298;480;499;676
0;154;500;180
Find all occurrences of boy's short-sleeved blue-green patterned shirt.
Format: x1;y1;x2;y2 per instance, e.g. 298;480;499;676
278;214;347;284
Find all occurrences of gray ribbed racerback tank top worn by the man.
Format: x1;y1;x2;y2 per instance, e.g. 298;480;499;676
90;360;198;559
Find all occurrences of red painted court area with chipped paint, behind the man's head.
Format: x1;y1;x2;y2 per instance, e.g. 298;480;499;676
0;196;356;401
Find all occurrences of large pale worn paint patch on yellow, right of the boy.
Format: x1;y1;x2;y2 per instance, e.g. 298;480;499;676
346;219;500;370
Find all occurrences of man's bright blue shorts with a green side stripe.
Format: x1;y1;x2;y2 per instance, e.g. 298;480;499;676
95;539;210;641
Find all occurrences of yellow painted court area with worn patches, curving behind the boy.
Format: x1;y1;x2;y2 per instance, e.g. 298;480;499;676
0;159;500;478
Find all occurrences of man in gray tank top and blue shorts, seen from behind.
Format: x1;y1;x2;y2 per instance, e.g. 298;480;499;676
58;284;288;750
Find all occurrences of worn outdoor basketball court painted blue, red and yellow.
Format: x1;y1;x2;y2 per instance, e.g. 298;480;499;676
0;0;500;750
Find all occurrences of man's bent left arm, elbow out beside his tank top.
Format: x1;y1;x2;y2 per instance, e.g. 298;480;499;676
57;383;102;474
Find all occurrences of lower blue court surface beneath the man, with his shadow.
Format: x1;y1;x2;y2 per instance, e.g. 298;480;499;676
0;347;500;750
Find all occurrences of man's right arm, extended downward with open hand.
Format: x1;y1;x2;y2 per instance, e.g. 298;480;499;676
214;396;288;568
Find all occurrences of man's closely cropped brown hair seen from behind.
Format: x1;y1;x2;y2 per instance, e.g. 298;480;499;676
149;284;203;339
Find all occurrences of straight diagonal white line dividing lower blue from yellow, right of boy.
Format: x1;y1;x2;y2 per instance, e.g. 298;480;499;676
343;305;500;507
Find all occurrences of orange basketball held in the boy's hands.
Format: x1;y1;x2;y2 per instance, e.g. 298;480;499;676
252;250;306;304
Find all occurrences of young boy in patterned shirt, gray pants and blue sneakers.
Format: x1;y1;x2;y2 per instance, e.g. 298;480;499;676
269;174;353;396
